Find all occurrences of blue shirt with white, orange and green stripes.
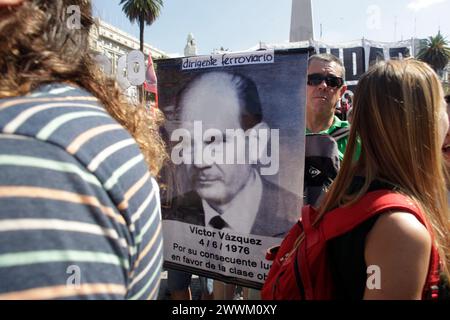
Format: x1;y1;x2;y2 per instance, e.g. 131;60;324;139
0;84;162;300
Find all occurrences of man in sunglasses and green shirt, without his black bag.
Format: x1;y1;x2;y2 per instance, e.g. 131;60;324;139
306;54;358;160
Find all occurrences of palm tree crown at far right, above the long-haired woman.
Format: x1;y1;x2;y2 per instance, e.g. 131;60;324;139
417;31;450;75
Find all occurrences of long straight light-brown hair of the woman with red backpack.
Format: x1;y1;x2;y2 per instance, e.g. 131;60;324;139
319;59;450;276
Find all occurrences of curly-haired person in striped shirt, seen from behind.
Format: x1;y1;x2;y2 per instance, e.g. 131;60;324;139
0;0;165;299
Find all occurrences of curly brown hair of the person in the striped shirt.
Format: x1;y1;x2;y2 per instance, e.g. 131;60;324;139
0;0;166;176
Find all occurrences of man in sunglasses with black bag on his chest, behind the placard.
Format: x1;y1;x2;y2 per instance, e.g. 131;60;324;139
303;54;360;206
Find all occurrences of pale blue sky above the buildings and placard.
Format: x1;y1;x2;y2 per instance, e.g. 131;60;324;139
93;0;450;54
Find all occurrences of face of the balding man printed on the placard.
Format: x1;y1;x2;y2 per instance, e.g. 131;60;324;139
180;76;253;205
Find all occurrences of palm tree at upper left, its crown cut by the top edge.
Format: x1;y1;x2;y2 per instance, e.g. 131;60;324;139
120;0;163;52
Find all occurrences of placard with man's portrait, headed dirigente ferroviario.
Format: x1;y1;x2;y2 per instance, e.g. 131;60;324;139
156;49;308;288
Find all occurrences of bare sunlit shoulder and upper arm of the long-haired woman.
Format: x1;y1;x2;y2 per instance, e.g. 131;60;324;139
364;212;432;300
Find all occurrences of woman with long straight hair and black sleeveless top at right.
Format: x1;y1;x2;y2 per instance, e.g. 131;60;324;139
319;60;450;299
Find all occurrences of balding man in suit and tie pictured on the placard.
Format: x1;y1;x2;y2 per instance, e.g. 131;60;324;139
164;71;300;237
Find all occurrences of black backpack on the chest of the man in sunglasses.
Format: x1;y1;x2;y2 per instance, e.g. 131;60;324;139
303;127;350;207
